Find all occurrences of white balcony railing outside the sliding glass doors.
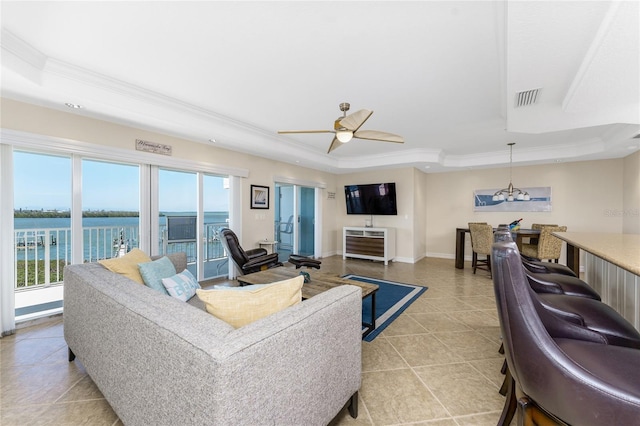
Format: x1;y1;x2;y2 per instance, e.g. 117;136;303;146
14;223;228;290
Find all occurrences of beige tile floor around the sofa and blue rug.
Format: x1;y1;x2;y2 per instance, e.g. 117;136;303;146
0;256;504;426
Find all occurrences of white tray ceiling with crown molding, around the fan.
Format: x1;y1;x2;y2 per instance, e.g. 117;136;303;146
0;0;640;173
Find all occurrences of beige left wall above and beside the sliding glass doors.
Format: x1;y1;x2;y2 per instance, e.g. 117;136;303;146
0;99;335;255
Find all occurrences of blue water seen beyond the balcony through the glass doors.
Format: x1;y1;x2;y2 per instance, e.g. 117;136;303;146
14;212;229;262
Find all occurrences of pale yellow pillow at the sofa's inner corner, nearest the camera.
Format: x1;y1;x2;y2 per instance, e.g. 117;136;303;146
196;275;304;328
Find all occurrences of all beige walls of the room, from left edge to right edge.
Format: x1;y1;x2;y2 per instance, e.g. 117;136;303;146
0;99;640;262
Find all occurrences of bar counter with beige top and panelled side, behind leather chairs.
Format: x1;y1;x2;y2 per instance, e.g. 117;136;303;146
554;232;640;330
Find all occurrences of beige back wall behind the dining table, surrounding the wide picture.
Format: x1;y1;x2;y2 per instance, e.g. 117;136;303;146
427;159;624;259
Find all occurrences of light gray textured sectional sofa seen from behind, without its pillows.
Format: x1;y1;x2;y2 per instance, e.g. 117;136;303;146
64;256;362;426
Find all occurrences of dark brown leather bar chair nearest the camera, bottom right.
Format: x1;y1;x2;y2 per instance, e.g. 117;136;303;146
491;242;640;425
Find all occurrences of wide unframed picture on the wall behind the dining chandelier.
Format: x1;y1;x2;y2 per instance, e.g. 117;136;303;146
473;186;551;212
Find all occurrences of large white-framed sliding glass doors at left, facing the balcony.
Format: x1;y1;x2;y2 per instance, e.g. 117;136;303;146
0;144;240;326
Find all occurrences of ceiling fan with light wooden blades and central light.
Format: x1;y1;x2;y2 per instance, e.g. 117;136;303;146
278;102;404;154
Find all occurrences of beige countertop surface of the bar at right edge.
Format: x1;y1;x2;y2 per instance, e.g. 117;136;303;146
553;232;640;275
